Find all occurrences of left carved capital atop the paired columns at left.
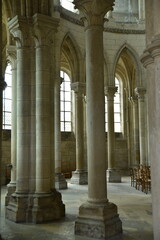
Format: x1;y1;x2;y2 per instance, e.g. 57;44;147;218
8;16;32;48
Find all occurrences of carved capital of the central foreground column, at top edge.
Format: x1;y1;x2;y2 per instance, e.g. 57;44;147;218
73;0;114;27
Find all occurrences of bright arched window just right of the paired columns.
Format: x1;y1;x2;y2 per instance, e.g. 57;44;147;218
60;71;72;132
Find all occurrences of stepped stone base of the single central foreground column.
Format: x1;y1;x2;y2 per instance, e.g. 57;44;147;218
75;203;122;240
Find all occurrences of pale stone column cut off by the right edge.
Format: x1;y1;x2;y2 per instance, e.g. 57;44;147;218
141;0;160;240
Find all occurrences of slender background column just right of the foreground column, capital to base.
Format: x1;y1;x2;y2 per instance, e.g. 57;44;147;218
105;86;121;182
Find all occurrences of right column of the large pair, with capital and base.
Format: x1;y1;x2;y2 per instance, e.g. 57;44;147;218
32;14;65;223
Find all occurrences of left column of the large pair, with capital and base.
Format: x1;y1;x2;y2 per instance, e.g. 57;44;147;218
6;16;34;222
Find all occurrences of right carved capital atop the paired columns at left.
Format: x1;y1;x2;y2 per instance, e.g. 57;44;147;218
33;13;59;47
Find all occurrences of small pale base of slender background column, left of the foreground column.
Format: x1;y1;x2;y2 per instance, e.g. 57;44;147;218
71;170;88;185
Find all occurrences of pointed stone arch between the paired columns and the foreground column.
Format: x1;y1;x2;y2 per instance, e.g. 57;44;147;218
61;32;84;82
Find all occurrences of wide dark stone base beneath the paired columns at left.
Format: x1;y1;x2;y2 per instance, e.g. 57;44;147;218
6;190;65;223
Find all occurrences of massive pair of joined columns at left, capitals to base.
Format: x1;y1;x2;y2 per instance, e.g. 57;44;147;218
6;14;65;223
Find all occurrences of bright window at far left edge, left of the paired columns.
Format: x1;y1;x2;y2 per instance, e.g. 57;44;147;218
3;63;12;129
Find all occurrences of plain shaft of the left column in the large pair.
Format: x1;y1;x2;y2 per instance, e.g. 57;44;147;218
16;47;30;193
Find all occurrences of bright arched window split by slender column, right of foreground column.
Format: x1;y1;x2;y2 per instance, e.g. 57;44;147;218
105;78;121;132
